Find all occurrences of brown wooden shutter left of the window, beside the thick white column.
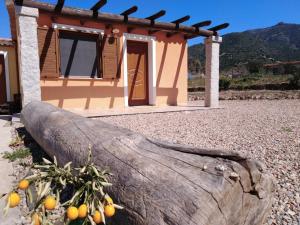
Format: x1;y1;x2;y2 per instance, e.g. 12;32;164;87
38;28;59;77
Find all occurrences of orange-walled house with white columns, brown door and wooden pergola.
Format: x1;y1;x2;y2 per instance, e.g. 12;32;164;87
6;0;224;110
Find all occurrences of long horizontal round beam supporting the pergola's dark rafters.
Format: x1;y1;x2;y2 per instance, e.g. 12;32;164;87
18;0;214;37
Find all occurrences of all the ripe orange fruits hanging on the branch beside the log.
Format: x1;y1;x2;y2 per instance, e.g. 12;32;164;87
8;179;115;225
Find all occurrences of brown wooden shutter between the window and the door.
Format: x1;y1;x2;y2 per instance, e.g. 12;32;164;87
102;35;120;79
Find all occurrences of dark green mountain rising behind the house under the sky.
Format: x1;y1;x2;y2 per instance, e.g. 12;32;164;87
189;22;300;73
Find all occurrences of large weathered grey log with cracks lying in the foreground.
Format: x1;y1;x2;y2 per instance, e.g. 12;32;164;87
21;102;273;225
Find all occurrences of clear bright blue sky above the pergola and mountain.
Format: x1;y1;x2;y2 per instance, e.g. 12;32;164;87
0;0;300;45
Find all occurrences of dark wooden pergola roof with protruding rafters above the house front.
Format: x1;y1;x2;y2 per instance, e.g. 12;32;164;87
15;0;229;39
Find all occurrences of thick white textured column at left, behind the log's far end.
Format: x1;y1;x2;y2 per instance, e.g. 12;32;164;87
16;6;41;107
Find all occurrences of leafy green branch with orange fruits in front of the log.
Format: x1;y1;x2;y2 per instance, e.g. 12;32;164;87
4;146;123;225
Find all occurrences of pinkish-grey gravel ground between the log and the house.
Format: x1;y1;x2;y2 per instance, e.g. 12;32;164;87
98;100;300;225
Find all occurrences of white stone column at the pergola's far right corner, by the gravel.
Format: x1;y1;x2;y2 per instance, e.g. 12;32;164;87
205;36;222;108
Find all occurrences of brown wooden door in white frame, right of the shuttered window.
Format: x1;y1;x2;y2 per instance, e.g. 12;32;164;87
127;41;148;106
